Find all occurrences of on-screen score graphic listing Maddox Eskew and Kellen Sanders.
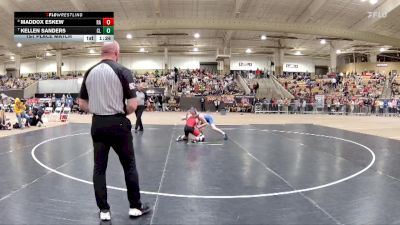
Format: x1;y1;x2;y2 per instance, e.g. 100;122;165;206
14;12;114;42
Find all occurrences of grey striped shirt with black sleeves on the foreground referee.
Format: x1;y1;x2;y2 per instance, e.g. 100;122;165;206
80;59;136;115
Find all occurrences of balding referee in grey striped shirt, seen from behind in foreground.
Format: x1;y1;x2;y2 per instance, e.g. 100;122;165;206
79;41;150;220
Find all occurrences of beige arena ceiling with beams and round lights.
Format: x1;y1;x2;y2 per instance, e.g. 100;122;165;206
0;0;400;62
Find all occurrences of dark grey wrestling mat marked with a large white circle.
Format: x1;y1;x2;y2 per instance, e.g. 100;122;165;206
0;117;400;224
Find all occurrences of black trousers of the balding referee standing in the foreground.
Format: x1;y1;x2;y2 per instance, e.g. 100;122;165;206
91;115;142;210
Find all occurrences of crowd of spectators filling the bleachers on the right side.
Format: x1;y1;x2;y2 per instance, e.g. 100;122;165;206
231;70;400;115
